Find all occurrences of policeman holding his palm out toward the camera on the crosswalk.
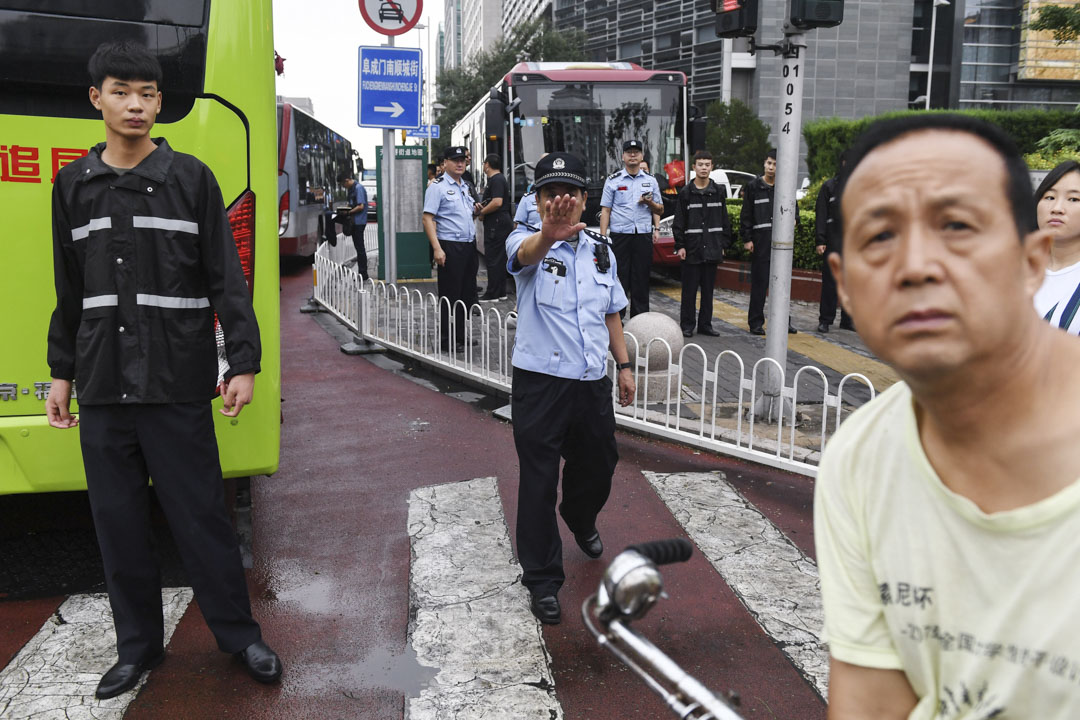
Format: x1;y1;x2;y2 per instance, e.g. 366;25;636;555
507;152;635;624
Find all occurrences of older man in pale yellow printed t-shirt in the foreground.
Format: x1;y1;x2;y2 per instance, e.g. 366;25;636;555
814;114;1080;720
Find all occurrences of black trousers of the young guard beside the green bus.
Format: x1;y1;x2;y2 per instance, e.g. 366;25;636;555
79;403;261;664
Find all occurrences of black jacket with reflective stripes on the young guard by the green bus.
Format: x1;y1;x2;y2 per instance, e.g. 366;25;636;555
48;138;261;405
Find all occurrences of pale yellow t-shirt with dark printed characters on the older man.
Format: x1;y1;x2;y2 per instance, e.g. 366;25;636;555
814;383;1080;720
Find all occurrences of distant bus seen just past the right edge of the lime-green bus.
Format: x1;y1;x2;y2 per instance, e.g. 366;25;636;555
278;103;356;257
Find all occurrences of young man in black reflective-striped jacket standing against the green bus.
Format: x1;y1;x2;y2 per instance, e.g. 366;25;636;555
45;43;282;698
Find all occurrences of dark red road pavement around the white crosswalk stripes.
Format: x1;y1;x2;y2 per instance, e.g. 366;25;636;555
118;269;825;720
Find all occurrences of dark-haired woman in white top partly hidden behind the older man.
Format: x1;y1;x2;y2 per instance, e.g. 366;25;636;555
1035;160;1080;335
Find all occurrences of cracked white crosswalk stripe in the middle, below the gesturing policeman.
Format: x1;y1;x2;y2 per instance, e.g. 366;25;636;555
405;477;563;720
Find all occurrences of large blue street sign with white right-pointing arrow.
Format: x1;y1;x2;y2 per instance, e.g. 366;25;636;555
356;47;423;130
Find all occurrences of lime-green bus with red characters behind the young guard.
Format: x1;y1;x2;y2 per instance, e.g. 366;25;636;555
0;0;281;494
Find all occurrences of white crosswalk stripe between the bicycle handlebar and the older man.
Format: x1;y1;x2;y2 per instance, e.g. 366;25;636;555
645;472;828;698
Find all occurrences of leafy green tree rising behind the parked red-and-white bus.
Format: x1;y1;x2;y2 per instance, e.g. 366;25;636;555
432;17;585;153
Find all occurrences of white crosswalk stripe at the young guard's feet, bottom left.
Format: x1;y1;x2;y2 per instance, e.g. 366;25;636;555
0;587;192;720
